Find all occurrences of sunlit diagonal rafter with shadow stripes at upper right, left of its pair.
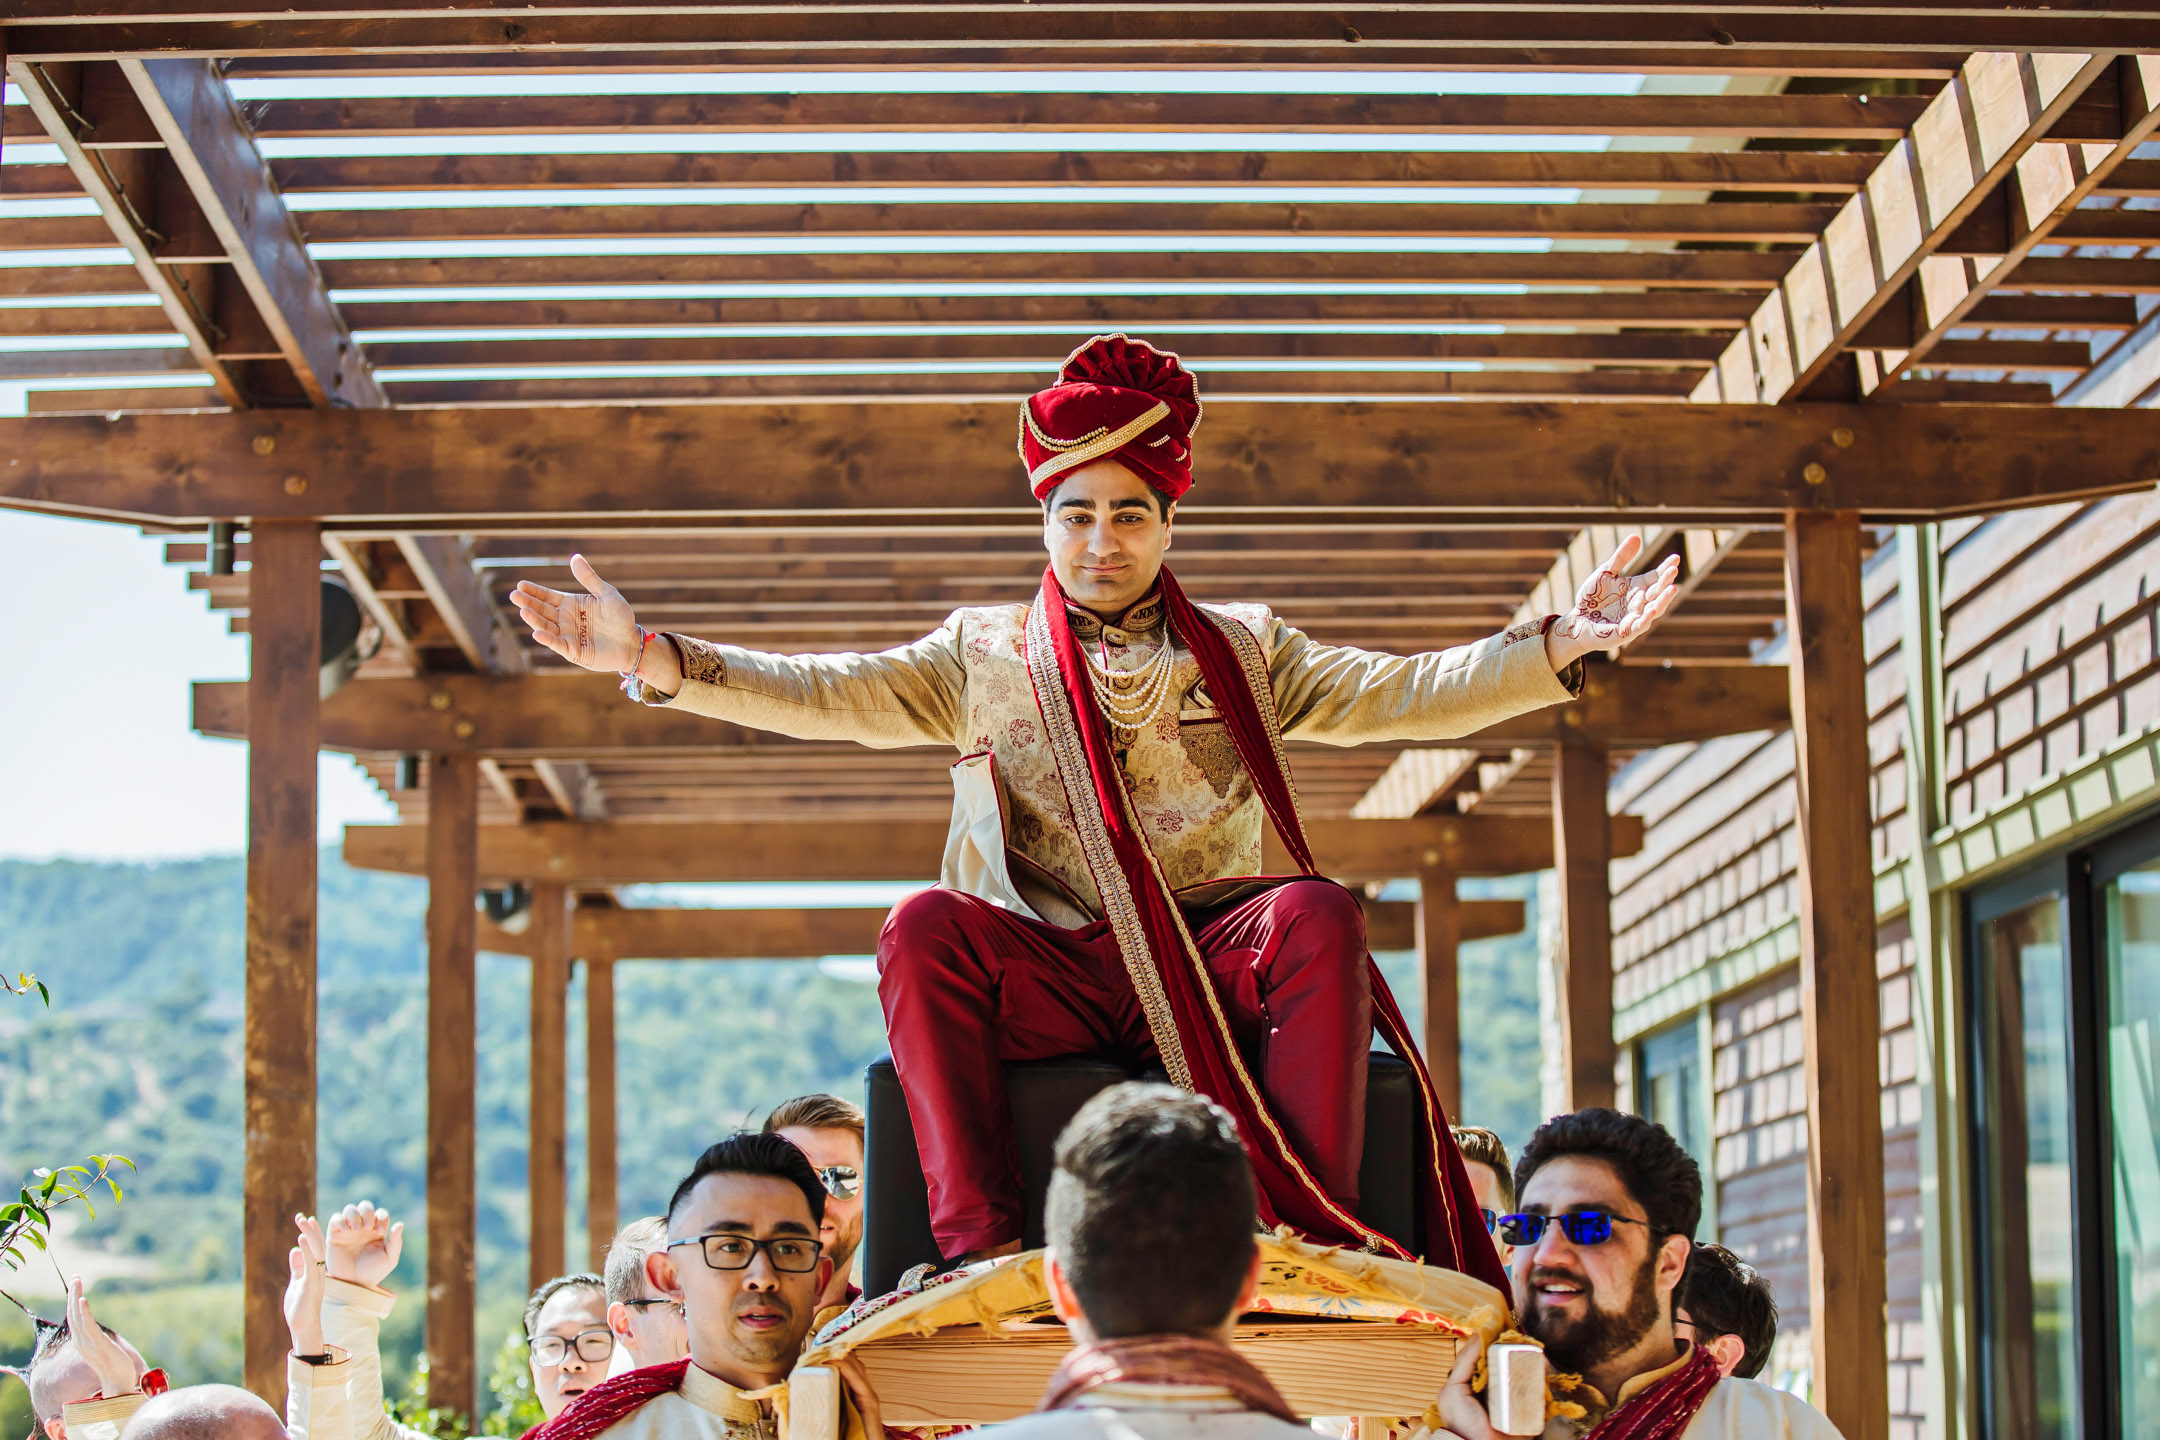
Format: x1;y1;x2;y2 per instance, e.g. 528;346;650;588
1693;52;2110;404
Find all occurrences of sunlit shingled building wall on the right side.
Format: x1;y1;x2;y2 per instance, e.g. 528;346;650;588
1611;492;2160;1440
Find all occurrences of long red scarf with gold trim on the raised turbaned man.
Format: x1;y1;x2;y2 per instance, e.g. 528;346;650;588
1026;570;1508;1293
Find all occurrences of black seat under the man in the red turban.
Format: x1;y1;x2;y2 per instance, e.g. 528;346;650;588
862;1051;1423;1295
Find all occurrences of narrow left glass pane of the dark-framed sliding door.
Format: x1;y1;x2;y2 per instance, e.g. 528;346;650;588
1974;894;2078;1440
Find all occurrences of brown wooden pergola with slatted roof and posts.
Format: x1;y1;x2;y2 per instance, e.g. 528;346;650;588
0;14;2160;1440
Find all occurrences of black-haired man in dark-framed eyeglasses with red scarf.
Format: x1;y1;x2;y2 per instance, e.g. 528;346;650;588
527;1136;883;1440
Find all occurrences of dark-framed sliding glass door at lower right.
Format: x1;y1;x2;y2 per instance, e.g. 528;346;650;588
1966;825;2160;1440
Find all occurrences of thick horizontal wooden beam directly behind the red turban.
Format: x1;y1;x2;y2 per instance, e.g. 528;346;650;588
0;402;2160;529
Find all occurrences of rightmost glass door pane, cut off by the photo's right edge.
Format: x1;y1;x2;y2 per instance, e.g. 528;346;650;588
2102;861;2160;1436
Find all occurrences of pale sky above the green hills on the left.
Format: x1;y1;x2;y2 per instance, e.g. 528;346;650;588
0;510;395;859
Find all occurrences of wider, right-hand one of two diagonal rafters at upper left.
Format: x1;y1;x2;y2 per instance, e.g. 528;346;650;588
121;60;382;406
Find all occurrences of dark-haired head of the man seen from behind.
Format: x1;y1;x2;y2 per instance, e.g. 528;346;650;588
1045;1084;1259;1341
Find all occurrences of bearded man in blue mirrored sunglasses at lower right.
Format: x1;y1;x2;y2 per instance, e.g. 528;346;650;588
1439;1110;1838;1440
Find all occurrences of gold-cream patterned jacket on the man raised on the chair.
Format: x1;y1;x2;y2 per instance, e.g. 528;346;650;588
642;596;1581;926
